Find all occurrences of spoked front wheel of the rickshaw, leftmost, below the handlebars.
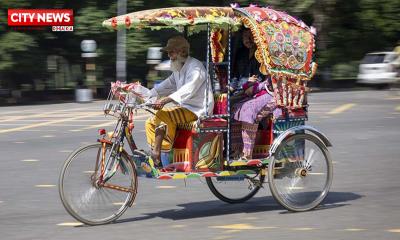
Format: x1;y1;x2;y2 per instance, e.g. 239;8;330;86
59;143;137;225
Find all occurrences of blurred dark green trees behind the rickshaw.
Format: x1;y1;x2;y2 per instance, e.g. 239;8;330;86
0;0;400;90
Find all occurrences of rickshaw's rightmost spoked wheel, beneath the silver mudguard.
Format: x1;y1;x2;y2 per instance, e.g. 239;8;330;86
268;134;333;212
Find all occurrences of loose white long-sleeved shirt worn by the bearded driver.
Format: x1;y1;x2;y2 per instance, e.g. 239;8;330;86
151;57;214;117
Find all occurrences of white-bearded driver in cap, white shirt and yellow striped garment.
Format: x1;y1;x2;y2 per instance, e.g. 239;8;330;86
145;36;214;166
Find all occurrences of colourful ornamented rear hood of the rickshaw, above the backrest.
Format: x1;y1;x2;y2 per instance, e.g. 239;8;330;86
238;7;315;79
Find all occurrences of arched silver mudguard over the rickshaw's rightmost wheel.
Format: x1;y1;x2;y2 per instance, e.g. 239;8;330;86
269;125;332;156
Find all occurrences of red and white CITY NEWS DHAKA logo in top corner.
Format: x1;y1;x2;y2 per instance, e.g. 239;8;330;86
8;9;74;32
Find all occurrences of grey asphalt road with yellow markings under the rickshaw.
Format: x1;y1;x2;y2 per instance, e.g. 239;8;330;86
0;91;400;240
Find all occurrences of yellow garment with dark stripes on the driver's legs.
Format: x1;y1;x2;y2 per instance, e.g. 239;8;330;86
146;107;197;151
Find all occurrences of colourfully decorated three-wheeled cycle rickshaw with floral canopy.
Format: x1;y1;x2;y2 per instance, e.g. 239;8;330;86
59;6;332;225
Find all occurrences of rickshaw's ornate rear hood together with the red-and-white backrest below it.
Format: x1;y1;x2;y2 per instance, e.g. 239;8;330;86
235;7;316;109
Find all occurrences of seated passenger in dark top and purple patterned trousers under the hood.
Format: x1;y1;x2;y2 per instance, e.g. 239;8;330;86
231;29;276;160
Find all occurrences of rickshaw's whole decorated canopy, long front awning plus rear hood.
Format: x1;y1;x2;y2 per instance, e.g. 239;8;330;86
103;6;316;81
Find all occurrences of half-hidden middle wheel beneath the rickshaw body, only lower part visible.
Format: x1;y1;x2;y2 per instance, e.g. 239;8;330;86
206;171;265;203
